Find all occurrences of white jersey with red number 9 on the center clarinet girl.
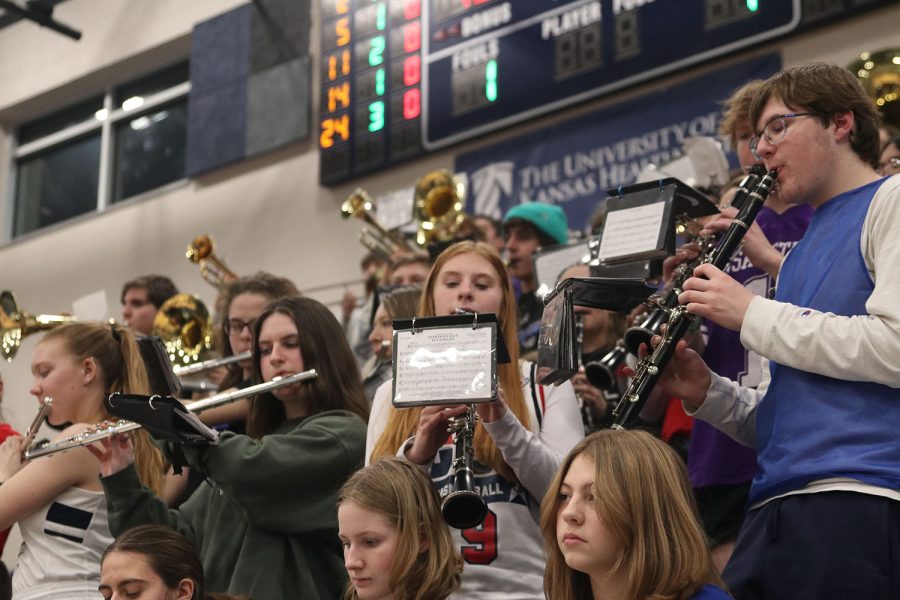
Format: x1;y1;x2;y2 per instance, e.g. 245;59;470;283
366;362;584;600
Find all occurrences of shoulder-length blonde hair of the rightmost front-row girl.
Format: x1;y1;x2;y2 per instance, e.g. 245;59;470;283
541;429;722;600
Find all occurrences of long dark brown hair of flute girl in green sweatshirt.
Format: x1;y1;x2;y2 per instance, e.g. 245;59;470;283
247;296;369;439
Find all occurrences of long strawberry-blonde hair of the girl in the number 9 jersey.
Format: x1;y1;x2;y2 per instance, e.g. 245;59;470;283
369;241;531;481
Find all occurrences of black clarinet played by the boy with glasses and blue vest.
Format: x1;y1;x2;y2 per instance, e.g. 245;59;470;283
612;171;778;429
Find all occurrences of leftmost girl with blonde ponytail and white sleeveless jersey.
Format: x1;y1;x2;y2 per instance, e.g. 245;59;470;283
0;323;164;600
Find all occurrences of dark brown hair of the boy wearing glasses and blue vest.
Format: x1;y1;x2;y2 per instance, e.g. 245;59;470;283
750;63;881;168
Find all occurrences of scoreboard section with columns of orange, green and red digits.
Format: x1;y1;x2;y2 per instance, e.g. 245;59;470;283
319;0;423;183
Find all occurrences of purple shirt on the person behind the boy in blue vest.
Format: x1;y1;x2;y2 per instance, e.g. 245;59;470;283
688;204;813;488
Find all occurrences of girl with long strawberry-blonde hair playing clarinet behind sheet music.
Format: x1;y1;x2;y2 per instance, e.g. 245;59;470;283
366;241;584;600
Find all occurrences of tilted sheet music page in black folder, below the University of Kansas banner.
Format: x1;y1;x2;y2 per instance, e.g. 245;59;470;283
599;202;666;262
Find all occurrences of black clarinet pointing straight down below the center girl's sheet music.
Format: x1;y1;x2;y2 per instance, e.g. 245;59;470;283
441;404;487;529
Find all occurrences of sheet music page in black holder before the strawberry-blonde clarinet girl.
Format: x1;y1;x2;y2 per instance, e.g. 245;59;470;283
393;325;497;407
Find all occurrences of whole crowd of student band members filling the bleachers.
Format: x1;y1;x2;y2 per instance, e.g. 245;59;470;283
0;64;900;600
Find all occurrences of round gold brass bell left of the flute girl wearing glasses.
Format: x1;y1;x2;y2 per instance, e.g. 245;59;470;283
153;294;212;368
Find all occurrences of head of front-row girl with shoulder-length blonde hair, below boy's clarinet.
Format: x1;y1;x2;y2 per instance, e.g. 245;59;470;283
541;429;730;600
